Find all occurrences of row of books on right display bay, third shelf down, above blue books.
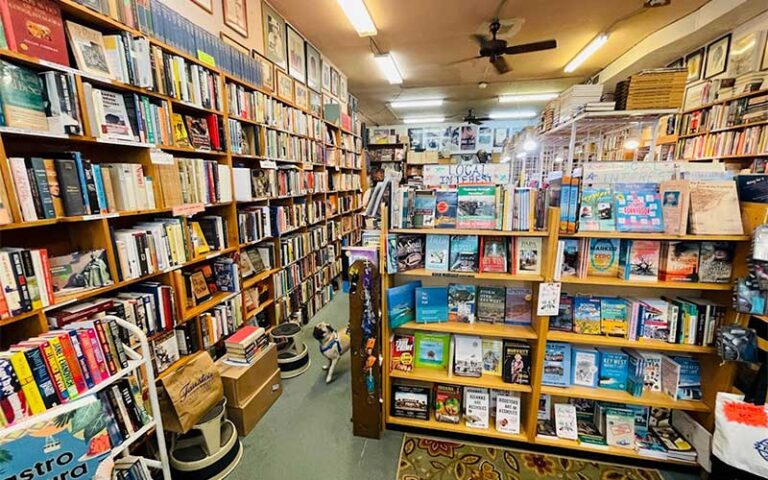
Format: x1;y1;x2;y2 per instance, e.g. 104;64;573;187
549;295;726;346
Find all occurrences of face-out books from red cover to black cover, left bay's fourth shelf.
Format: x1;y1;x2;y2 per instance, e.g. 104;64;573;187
390;332;531;385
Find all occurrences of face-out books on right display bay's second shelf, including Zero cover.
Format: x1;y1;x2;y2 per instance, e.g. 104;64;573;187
557;238;735;283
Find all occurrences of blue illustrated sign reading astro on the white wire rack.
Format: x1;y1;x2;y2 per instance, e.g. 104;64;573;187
0;396;112;480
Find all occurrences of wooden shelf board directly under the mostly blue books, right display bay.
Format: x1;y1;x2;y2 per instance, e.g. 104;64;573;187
541;385;711;412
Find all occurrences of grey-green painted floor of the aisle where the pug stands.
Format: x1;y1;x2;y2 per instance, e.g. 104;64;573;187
228;294;698;480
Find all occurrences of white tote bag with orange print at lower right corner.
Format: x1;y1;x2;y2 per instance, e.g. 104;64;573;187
712;392;768;478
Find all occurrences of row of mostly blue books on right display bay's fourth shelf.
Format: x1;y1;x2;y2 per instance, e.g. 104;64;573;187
541;342;702;400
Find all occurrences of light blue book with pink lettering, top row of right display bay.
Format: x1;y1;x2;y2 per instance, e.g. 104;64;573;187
614;183;664;232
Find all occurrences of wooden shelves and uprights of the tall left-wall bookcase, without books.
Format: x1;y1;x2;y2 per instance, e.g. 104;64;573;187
0;0;364;463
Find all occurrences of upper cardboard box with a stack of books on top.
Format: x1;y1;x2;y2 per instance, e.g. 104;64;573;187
216;344;278;407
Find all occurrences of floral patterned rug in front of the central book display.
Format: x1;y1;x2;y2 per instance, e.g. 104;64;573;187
397;434;663;480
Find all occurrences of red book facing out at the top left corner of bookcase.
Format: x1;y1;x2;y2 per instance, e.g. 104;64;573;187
0;0;69;66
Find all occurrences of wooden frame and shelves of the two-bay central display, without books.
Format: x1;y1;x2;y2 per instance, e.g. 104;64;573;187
380;194;752;466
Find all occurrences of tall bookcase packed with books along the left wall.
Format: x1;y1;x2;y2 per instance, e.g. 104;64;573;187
0;0;362;434
